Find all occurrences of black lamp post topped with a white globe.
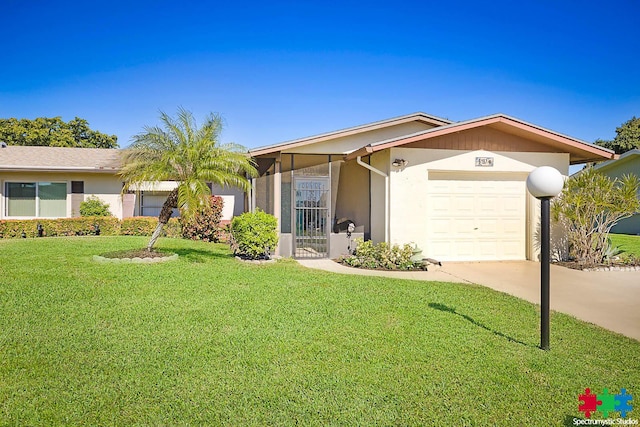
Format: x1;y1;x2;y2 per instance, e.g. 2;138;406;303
527;166;564;350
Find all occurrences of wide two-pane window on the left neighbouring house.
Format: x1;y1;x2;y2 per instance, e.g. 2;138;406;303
6;182;67;218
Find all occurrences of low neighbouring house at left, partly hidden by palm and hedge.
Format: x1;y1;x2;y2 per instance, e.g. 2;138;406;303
0;145;245;220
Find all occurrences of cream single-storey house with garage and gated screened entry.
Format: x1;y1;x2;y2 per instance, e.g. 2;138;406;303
249;113;615;261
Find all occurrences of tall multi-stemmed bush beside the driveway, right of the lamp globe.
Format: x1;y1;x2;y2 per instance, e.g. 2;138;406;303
552;168;640;265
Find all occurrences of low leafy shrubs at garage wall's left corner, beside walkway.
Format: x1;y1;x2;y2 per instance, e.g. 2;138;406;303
340;238;422;270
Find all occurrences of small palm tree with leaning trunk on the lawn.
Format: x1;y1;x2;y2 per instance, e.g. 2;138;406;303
120;108;257;251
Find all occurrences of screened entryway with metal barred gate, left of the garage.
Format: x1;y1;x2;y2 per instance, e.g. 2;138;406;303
248;153;370;258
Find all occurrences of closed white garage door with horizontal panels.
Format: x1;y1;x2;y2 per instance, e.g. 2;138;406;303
426;172;526;261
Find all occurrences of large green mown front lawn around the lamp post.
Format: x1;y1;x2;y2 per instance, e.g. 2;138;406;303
0;237;640;426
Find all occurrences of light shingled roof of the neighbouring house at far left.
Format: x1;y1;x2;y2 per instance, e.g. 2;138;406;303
0;145;121;173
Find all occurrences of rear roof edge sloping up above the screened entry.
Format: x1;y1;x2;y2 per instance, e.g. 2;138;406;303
249;112;452;157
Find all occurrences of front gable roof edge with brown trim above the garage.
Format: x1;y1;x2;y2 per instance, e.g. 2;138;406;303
346;114;616;164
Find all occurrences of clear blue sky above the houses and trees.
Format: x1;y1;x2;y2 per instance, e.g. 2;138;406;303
0;0;640;152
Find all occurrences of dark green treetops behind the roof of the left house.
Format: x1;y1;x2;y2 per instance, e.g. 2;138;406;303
0;117;118;148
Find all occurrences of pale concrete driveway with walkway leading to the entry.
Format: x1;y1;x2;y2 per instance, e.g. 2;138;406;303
298;259;640;341
